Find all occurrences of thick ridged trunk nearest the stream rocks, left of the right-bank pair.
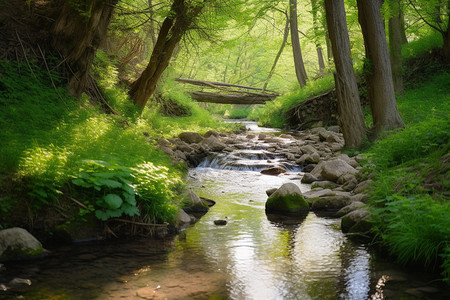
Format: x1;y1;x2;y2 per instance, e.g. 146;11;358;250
325;0;366;148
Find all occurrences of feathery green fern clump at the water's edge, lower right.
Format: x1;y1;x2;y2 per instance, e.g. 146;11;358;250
372;194;450;271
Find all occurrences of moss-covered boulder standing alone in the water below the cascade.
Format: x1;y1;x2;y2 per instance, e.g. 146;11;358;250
266;182;309;213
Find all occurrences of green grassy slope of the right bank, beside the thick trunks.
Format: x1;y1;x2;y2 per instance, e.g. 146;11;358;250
365;71;450;281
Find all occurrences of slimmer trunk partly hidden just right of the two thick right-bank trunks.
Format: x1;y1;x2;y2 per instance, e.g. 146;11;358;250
389;0;403;94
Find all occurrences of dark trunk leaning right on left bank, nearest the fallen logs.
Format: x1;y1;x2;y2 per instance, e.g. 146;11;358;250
129;0;202;109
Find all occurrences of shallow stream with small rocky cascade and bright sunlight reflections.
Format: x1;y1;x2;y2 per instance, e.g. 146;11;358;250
0;122;450;300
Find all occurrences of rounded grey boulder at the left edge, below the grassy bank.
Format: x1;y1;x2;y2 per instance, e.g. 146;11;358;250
0;227;45;259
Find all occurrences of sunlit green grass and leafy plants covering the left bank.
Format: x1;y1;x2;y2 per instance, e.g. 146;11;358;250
0;57;237;227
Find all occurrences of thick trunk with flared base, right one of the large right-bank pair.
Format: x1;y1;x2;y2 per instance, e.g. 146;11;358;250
356;0;404;137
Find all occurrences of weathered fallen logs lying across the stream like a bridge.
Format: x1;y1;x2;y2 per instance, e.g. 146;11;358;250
175;78;280;105
